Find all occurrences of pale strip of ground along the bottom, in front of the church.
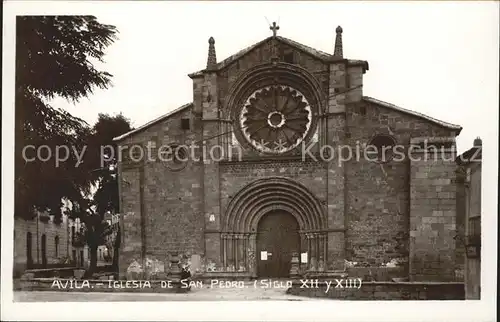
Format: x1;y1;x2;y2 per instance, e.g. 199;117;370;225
14;283;319;302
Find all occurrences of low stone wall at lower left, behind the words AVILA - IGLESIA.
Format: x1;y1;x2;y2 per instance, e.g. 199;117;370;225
14;278;191;293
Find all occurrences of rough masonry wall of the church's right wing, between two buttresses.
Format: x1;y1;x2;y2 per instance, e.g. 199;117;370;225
345;101;452;267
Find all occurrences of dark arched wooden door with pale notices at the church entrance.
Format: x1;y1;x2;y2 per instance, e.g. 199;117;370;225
256;211;300;278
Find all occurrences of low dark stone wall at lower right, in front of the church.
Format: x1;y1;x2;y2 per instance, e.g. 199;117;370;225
287;281;465;300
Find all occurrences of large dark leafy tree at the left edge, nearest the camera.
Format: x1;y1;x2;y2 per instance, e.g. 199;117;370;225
14;16;117;220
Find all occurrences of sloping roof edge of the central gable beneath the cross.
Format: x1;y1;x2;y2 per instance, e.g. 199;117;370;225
188;36;368;78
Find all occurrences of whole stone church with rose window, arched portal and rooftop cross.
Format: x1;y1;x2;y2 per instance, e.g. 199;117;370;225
115;25;463;281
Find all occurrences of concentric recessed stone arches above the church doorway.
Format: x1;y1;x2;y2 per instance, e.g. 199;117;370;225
223;177;326;232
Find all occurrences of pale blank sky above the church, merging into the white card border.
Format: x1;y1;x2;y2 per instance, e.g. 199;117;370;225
15;1;499;151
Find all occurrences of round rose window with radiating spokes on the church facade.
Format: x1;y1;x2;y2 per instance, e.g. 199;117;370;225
240;85;312;153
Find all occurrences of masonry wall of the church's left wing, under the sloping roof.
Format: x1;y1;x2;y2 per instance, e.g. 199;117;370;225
120;108;204;277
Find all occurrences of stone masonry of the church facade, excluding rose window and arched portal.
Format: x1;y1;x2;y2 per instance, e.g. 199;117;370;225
120;33;460;276
